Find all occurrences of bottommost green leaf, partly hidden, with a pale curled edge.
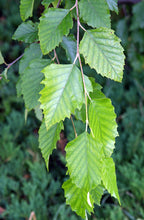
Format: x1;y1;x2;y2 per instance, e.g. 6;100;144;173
62;179;93;218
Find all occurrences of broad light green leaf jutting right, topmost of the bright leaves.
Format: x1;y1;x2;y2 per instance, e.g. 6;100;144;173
80;28;124;82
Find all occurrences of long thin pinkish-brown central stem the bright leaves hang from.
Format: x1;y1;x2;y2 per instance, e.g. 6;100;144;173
75;0;88;131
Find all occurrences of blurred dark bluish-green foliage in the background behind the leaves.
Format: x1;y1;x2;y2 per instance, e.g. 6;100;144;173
0;0;144;220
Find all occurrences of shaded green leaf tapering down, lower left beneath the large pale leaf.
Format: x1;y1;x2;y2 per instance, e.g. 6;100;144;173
39;121;63;169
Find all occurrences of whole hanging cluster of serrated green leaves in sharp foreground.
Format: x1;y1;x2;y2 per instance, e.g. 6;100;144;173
1;0;124;218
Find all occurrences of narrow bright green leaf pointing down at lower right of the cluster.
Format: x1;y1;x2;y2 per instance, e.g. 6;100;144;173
102;158;121;204
